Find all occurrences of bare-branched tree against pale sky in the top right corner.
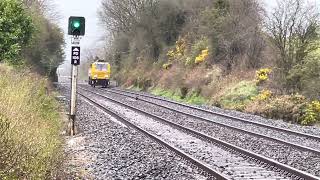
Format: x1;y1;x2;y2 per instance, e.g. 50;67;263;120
266;0;319;74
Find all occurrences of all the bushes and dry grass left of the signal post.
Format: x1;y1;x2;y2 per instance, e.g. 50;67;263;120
0;0;64;179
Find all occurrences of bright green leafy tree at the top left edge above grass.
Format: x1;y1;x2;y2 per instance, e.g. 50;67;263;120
0;0;34;64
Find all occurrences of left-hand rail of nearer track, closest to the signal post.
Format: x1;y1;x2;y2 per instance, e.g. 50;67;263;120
78;92;228;180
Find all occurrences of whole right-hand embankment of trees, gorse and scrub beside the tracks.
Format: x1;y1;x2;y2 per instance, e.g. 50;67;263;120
95;0;320;125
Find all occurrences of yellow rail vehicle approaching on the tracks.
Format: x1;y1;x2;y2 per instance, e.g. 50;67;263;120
88;61;111;87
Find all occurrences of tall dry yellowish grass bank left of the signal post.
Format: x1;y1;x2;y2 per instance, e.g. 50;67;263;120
0;64;62;179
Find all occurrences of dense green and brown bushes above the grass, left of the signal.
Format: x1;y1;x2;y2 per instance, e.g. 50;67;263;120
0;0;64;78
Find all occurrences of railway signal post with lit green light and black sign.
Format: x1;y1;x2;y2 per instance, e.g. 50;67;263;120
68;16;85;136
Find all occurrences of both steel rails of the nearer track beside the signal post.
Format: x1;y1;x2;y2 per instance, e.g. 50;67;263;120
80;88;318;179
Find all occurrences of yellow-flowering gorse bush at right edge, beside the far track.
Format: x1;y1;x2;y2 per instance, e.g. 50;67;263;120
301;101;320;125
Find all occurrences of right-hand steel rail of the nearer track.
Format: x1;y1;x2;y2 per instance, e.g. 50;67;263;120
80;88;319;180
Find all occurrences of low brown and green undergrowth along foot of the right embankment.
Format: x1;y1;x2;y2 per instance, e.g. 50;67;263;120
122;62;320;125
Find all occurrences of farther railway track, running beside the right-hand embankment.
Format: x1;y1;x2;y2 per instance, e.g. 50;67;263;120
99;87;320;155
